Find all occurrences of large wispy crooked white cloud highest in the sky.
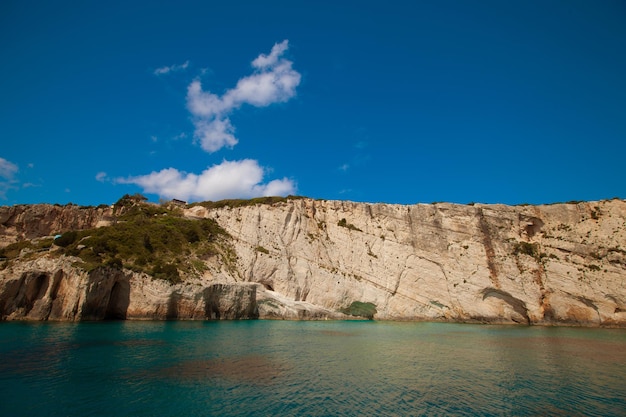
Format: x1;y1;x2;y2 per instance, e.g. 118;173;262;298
187;40;301;152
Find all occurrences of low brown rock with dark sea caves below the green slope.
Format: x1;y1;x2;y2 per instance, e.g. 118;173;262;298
0;257;259;321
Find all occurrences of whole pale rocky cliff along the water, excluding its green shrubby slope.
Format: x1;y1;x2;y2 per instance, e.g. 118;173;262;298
0;199;626;326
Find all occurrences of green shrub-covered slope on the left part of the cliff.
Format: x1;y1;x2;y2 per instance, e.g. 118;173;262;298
0;195;234;283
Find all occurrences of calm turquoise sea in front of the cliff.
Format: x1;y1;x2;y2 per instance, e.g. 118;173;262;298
0;321;626;416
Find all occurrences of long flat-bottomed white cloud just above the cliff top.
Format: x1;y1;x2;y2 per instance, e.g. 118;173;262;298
116;159;296;201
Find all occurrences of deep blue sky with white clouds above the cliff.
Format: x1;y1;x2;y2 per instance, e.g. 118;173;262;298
0;0;626;205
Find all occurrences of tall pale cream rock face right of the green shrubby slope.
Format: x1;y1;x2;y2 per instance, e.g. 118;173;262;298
187;199;626;325
